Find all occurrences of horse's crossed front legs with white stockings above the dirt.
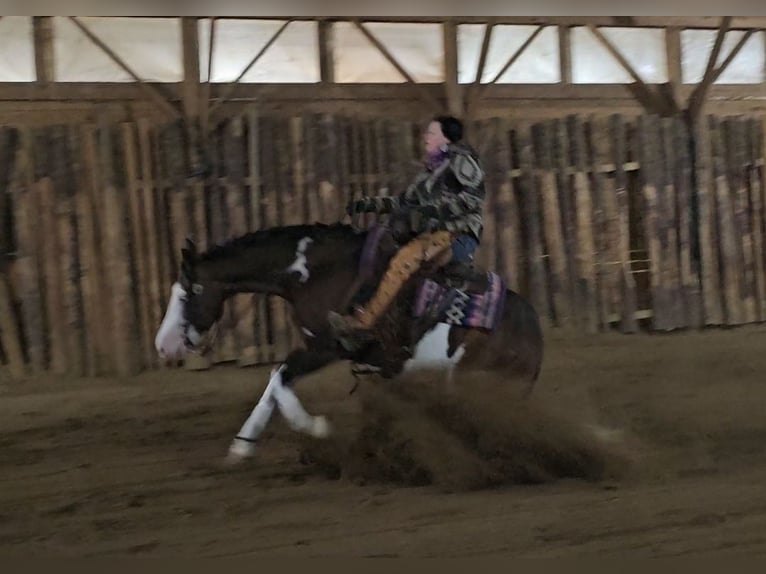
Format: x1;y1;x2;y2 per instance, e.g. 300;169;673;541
229;350;338;461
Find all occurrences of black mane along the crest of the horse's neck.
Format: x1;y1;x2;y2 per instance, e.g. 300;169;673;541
197;223;365;262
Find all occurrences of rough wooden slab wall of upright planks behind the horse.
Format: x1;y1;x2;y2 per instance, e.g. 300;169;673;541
0;108;766;376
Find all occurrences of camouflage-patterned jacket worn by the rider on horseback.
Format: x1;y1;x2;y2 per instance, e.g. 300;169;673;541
352;144;485;244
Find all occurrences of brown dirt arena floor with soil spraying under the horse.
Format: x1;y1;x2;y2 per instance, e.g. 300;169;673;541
0;327;766;557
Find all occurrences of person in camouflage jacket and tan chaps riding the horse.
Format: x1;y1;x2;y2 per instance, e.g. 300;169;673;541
328;112;485;347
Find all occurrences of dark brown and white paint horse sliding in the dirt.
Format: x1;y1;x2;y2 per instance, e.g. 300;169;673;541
155;223;543;461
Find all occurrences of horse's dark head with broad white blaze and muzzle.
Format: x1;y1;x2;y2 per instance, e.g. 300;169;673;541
154;239;226;361
